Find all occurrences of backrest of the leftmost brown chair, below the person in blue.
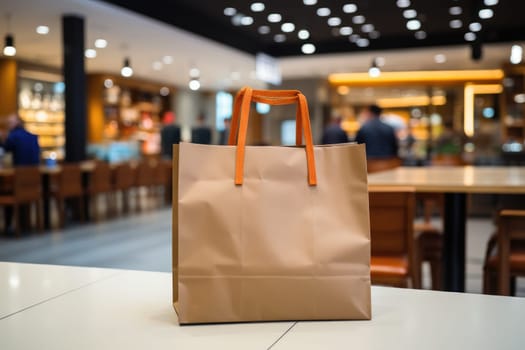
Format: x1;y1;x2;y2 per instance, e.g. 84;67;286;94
13;166;42;202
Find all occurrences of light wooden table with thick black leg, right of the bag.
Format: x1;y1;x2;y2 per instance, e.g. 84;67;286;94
368;166;525;292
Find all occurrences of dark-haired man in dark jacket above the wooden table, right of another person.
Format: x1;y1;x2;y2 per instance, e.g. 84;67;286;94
355;105;398;158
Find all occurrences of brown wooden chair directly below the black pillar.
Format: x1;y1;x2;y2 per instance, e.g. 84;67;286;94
50;164;84;227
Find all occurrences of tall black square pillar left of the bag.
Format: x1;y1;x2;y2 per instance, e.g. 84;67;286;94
62;15;87;162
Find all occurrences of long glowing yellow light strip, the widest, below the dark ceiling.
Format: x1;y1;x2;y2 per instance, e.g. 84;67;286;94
328;69;504;86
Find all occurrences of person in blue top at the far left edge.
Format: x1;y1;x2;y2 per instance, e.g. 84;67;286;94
2;114;40;166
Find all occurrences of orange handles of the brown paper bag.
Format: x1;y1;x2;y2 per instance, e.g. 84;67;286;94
228;87;317;186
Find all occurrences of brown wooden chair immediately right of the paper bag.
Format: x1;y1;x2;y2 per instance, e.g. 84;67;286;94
369;187;421;288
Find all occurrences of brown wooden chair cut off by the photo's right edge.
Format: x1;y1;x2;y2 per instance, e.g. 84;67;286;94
483;210;525;295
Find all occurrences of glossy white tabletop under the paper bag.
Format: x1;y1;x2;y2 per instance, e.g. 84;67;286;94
0;263;525;350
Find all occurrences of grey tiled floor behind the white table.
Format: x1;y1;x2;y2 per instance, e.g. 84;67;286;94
0;209;525;296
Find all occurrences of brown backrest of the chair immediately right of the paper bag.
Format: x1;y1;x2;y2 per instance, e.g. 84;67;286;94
369;187;415;263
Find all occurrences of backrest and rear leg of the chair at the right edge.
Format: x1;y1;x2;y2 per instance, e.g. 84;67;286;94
498;210;525;295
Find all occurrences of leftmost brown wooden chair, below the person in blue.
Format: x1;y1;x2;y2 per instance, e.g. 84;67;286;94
0;166;43;235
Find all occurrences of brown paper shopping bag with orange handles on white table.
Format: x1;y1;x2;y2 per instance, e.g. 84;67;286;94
173;88;371;324
